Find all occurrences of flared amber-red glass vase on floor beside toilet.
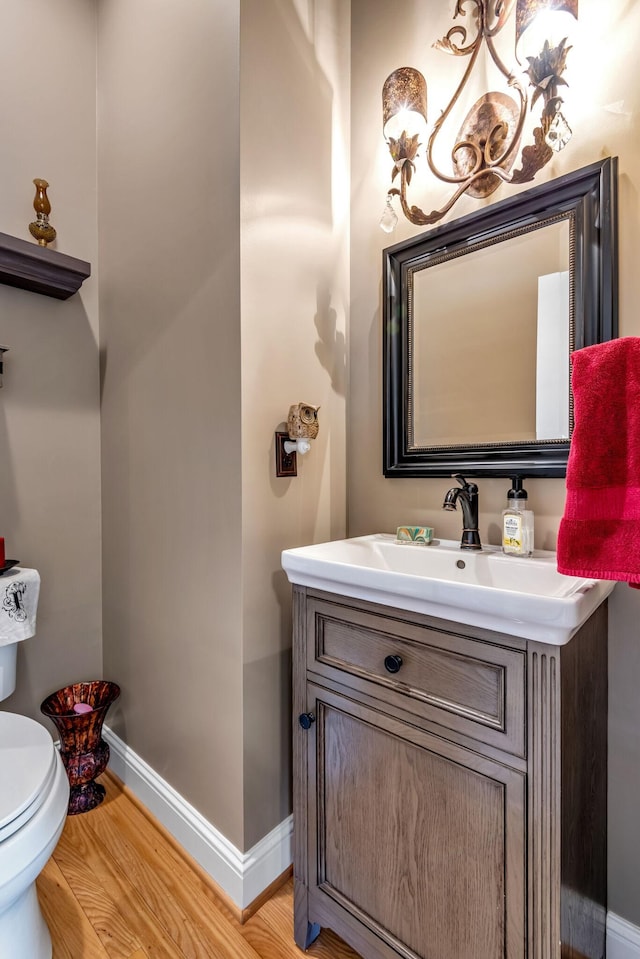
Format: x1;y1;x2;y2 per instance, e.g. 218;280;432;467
40;679;120;816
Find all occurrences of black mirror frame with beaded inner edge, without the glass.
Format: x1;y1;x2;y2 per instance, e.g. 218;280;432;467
383;157;618;477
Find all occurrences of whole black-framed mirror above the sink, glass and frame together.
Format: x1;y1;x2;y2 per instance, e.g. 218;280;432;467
384;158;617;477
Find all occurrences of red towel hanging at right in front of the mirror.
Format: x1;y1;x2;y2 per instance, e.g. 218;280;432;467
558;336;640;588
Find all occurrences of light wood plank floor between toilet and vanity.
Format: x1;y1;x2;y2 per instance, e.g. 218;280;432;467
38;774;359;959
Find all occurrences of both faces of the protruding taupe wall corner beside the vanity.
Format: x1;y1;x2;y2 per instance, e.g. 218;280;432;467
98;0;348;850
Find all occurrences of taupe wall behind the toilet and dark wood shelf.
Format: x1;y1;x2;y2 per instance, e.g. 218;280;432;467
0;0;102;730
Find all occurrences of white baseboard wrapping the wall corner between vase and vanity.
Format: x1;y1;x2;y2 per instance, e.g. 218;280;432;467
104;726;293;909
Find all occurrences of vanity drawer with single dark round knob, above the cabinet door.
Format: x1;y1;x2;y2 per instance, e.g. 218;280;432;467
307;597;526;756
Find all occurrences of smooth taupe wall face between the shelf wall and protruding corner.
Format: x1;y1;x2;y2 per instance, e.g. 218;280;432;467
98;0;243;848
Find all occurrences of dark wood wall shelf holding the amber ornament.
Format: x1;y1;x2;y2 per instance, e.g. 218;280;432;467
0;233;91;300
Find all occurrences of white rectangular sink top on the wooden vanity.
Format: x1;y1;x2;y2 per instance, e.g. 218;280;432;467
282;533;615;646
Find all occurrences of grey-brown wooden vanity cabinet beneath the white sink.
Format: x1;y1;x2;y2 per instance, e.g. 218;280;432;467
293;587;607;959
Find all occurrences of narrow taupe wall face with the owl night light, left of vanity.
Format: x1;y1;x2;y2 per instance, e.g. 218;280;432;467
240;0;349;848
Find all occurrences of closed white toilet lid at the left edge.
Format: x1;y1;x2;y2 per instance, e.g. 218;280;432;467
0;712;57;843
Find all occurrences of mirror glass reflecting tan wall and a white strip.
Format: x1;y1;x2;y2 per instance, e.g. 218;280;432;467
407;216;573;449
